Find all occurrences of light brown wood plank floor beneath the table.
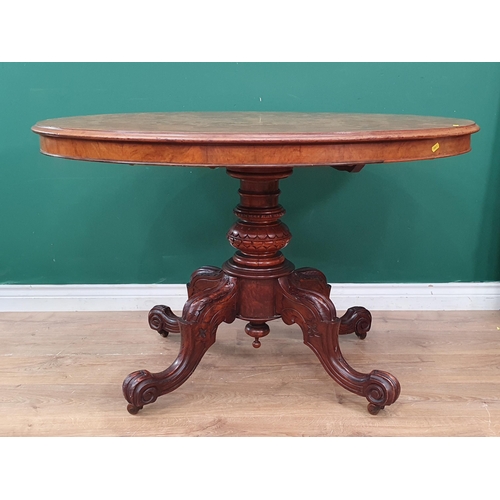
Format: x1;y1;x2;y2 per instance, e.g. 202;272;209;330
0;311;500;436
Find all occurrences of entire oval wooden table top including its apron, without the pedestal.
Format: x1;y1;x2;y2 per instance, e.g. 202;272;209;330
32;112;479;166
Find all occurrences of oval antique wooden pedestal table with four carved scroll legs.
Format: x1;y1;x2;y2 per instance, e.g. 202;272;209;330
32;112;479;414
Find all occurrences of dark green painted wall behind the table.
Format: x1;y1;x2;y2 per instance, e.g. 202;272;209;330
0;63;500;284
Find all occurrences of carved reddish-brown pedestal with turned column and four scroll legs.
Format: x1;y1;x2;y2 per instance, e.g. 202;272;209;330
123;166;400;414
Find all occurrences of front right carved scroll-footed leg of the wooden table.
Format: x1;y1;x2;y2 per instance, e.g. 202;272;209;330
278;269;400;414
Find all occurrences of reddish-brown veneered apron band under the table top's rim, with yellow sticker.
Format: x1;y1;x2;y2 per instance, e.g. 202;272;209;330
40;135;471;167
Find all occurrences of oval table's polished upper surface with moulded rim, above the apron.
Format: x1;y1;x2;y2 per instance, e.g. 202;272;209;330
33;111;478;143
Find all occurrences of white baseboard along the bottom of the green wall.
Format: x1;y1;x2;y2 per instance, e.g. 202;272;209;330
0;282;500;312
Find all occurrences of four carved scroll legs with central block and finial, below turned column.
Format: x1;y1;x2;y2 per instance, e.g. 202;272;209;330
123;267;400;414
